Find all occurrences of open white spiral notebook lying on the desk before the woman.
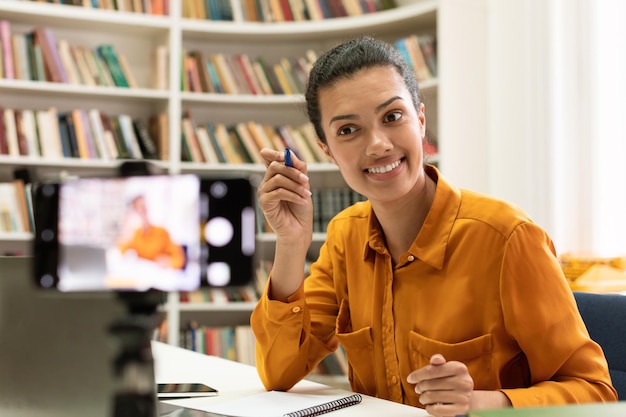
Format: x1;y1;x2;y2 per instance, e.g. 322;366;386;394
184;391;362;417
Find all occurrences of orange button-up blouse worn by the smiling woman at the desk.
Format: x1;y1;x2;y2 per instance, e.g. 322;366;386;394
251;167;617;406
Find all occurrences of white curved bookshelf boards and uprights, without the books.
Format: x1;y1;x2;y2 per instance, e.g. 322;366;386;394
0;0;439;384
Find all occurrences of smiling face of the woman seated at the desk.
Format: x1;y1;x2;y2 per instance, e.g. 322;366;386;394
319;67;426;202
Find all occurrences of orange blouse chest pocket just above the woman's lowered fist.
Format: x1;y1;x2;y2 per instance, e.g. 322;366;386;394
409;332;496;389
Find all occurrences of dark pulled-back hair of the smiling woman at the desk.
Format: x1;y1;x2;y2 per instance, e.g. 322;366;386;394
305;36;419;143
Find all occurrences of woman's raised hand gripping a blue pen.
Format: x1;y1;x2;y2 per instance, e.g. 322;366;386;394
257;148;313;248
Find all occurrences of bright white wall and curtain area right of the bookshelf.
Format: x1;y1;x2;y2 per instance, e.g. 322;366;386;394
438;0;626;256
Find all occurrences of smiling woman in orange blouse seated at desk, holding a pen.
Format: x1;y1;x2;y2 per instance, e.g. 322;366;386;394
251;37;616;416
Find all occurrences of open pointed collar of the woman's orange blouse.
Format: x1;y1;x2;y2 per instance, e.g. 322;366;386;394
363;165;461;269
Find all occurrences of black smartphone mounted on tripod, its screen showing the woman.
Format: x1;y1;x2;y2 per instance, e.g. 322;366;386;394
33;174;256;292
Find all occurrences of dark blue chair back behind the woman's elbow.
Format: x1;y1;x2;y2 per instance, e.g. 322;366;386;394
574;291;626;400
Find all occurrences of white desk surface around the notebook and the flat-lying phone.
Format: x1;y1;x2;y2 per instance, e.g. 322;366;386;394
152;342;429;417
